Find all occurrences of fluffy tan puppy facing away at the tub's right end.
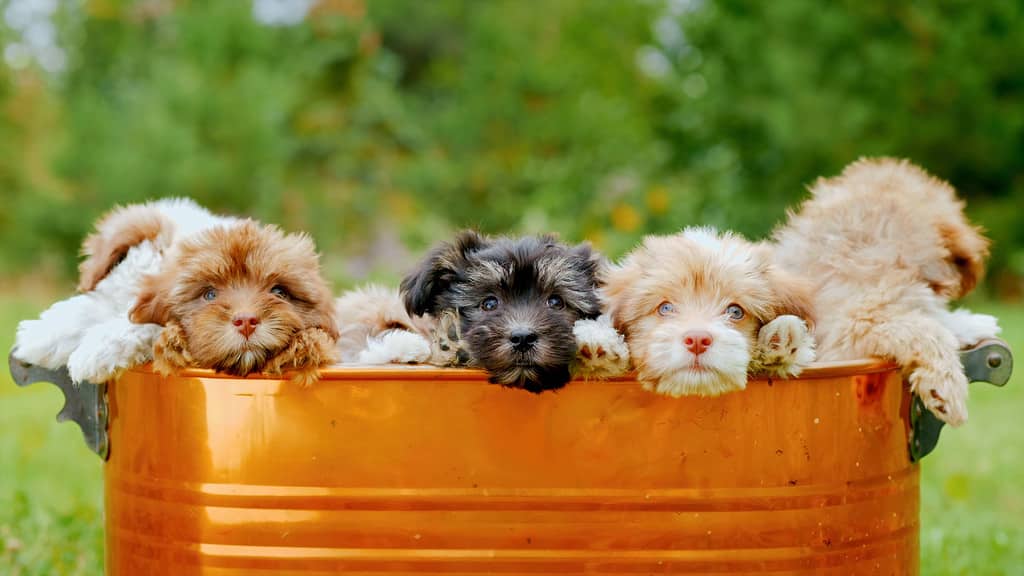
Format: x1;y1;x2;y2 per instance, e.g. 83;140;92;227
774;154;999;425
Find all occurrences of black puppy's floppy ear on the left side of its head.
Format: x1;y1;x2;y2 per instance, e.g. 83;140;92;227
400;230;489;316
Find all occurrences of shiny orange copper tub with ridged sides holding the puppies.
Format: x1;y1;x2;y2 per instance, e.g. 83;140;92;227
105;362;919;576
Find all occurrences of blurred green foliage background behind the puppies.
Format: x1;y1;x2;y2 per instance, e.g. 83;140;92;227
0;0;1024;289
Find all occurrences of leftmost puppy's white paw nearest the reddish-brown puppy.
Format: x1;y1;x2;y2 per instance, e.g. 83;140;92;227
68;319;163;384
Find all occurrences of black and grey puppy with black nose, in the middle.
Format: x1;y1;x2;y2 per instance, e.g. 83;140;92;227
401;231;603;393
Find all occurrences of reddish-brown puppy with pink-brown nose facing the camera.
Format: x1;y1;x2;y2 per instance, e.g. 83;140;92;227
129;220;338;385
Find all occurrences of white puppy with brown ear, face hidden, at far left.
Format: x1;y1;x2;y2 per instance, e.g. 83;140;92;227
13;199;236;383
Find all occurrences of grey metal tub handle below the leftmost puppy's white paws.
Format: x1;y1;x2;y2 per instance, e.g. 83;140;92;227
7;351;110;460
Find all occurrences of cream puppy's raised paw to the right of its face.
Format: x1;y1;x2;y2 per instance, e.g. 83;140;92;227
750;315;814;377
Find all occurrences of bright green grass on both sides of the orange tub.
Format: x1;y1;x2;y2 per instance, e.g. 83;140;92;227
0;295;1024;576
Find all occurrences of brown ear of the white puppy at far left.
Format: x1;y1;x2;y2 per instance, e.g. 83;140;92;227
78;205;172;292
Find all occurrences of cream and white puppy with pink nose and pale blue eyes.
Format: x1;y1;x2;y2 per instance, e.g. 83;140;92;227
603;228;814;396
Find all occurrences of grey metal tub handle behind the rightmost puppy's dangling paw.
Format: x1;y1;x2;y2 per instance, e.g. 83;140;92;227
909;339;1014;462
